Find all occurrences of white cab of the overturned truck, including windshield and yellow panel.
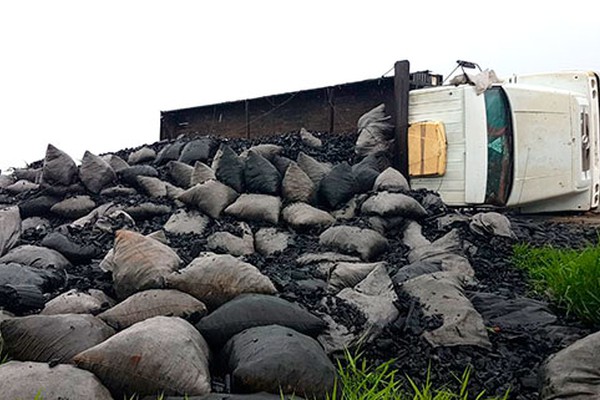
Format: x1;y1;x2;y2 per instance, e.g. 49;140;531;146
408;71;600;212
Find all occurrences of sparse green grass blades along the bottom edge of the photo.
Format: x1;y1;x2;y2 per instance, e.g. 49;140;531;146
328;352;509;400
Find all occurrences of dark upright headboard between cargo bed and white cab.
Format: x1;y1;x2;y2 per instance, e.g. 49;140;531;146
393;60;410;179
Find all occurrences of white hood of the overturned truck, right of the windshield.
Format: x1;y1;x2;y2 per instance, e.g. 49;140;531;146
504;84;590;212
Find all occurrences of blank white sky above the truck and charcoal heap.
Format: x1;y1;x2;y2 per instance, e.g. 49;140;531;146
0;0;600;169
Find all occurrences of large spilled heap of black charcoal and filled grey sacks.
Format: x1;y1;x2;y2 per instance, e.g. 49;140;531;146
0;109;600;399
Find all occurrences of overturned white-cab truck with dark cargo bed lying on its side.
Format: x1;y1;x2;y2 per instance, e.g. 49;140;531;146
161;61;600;213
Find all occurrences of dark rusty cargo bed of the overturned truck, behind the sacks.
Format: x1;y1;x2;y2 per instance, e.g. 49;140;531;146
160;77;394;139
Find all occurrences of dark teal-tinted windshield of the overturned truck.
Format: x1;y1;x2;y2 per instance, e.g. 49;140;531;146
484;86;513;206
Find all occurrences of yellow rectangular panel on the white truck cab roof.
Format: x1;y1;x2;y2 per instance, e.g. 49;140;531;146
408;121;446;176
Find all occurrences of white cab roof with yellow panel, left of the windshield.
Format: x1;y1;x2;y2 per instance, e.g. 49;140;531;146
409;85;488;206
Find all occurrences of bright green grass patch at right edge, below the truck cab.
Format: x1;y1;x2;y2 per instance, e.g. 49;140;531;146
513;244;600;325
